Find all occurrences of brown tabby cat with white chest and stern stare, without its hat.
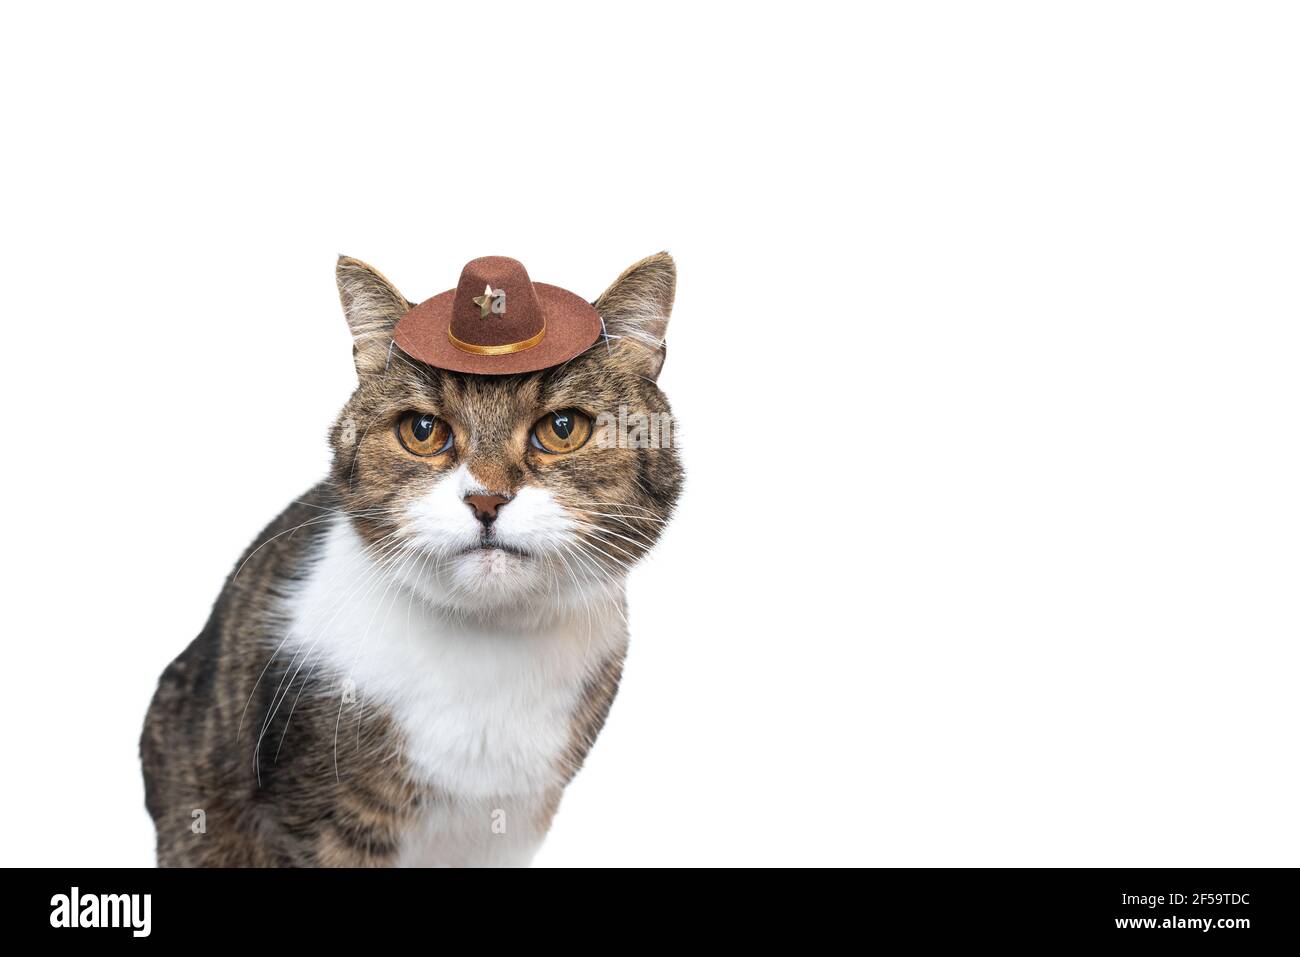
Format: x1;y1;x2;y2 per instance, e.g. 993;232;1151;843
140;254;683;867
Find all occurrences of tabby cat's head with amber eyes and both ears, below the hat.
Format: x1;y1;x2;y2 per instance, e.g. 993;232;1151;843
330;254;681;615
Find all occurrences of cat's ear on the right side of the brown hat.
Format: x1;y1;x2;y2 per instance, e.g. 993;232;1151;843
595;252;677;378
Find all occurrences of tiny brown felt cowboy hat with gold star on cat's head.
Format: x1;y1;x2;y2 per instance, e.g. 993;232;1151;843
393;256;601;376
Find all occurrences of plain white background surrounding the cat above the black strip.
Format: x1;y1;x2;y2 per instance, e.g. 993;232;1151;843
0;3;1300;866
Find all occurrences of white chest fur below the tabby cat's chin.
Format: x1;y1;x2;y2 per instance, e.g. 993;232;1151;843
280;520;625;865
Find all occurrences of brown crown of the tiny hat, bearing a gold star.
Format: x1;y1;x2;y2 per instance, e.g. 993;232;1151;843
451;256;546;348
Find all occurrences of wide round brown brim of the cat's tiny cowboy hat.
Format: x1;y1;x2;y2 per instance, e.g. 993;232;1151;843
393;282;601;376
